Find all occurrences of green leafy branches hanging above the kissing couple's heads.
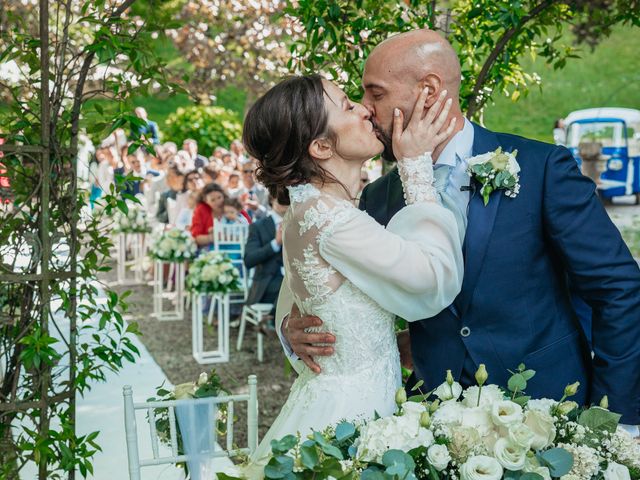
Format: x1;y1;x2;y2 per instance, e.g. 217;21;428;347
288;0;640;117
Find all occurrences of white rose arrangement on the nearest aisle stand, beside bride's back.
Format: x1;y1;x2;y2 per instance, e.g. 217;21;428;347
186;252;240;294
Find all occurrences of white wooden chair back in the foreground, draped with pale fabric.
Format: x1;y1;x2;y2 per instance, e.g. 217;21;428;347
123;375;258;480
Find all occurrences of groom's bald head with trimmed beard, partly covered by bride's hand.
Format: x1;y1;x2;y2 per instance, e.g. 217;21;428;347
362;29;463;161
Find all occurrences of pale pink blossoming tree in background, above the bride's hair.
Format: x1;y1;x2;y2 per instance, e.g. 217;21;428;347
168;0;302;104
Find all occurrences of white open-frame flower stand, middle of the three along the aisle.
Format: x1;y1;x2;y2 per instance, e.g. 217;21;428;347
153;260;185;321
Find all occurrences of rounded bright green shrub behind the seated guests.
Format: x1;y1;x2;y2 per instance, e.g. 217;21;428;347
163;105;242;156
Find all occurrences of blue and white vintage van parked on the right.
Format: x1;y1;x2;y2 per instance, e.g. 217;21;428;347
565;108;640;203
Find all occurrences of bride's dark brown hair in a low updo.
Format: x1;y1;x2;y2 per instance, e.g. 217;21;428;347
242;75;341;205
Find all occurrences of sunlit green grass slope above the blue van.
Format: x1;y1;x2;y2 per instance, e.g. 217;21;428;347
484;28;640;142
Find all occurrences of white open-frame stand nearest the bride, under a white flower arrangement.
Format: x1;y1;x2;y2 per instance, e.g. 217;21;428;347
191;292;229;364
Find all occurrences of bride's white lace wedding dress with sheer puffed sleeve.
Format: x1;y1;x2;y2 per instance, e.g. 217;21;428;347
245;154;464;479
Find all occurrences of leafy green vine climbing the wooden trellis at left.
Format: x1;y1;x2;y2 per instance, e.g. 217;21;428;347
0;0;186;480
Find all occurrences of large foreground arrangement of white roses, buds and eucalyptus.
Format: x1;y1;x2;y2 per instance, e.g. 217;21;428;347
256;365;640;480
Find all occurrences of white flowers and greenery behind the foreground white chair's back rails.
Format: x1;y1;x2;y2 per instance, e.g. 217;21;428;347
147;370;229;468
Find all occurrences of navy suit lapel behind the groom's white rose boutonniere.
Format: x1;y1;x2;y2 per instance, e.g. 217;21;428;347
455;123;504;317
